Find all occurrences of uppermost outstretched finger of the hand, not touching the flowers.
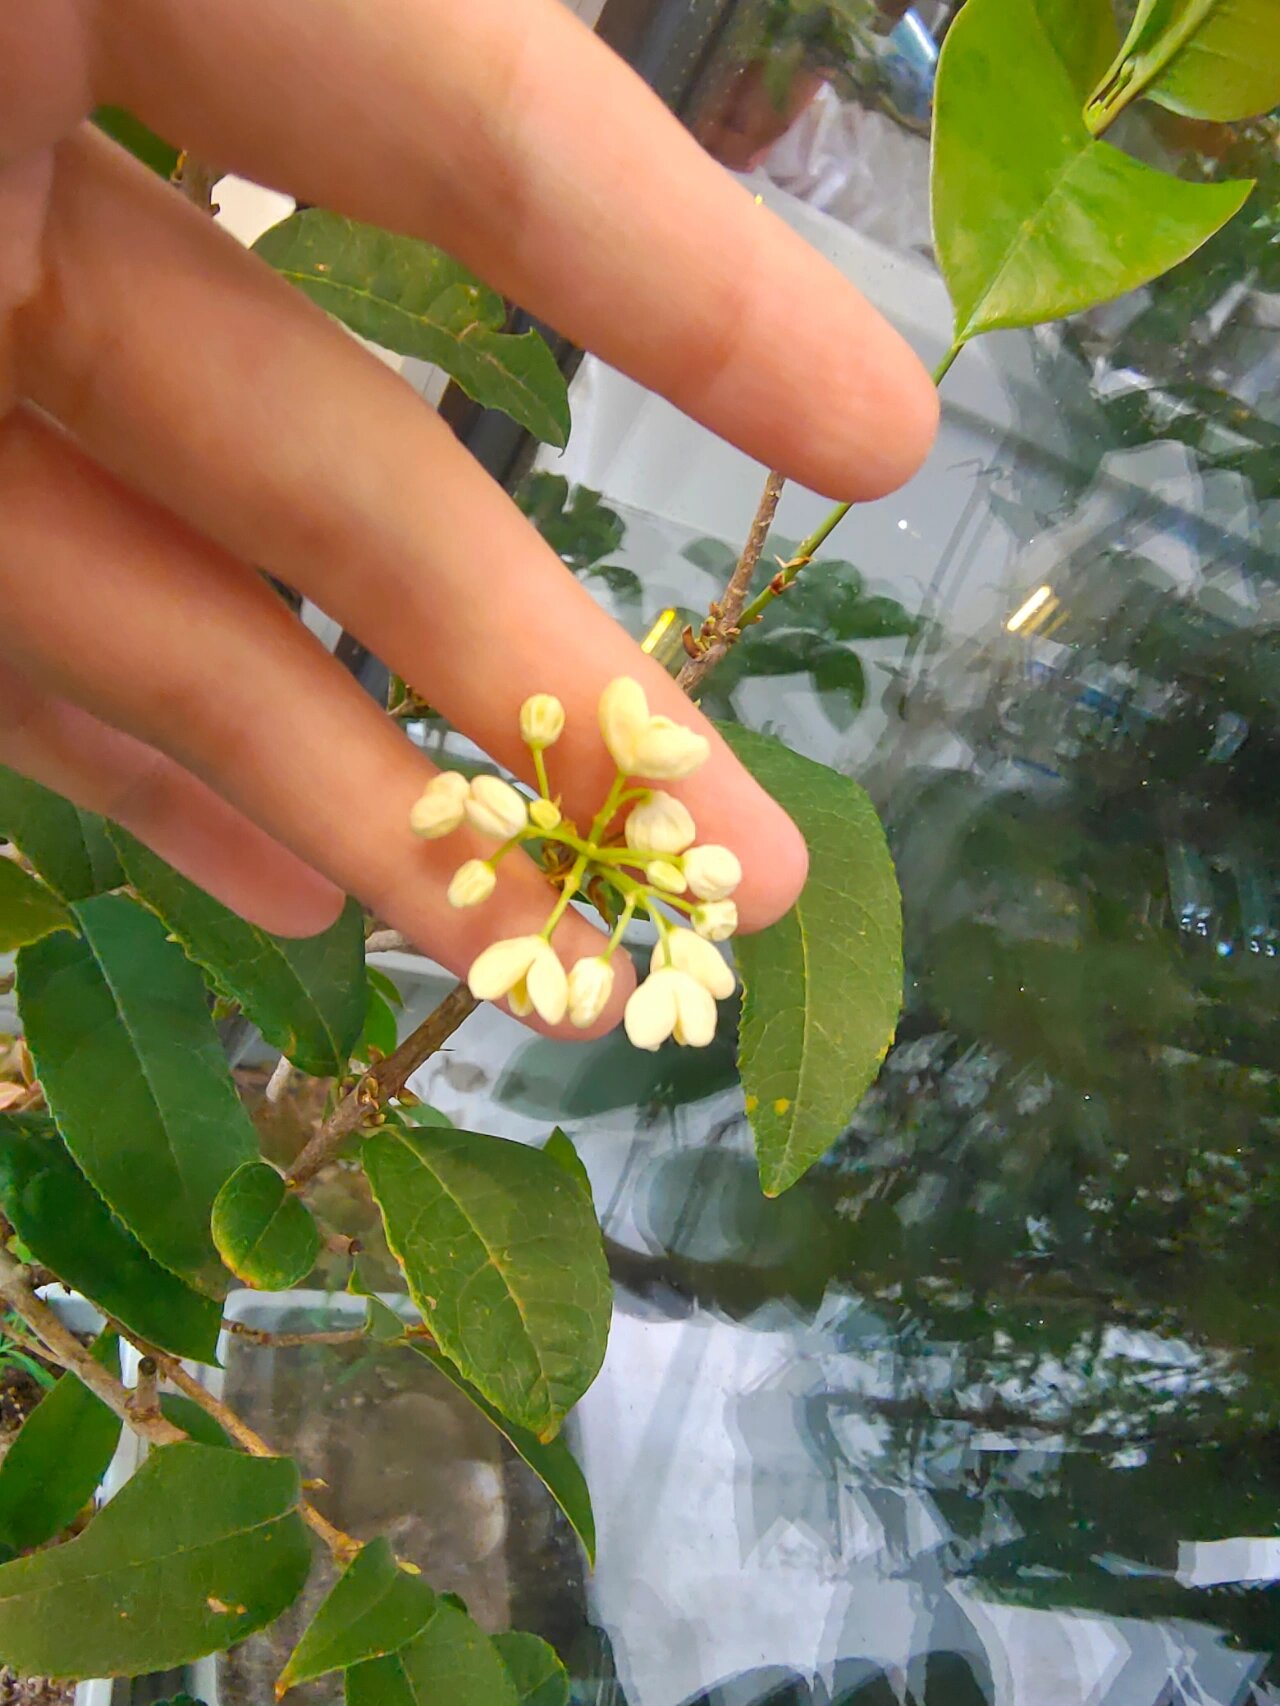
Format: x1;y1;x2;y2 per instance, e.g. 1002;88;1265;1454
84;0;937;498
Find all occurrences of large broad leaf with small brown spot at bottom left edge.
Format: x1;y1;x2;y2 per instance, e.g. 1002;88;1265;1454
0;1445;311;1677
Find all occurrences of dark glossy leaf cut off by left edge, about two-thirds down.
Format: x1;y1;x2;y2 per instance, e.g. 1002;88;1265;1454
0;1114;222;1363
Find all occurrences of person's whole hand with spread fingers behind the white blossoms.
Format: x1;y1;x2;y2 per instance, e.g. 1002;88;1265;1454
0;0;937;1022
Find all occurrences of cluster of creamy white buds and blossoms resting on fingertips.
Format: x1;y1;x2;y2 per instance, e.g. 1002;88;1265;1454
410;676;742;1049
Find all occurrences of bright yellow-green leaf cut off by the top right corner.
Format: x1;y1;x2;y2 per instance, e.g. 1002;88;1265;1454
1085;0;1280;133
